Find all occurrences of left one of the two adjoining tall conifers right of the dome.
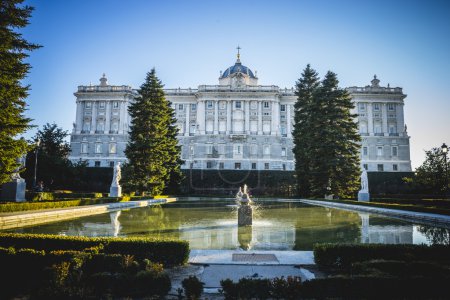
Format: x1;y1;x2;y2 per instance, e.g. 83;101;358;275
292;64;320;197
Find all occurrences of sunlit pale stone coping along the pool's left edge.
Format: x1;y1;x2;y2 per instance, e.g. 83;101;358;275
0;198;176;230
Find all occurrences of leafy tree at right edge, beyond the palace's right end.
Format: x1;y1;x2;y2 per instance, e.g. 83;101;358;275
405;147;450;195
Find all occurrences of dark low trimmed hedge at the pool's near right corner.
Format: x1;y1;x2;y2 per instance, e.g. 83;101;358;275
314;244;450;269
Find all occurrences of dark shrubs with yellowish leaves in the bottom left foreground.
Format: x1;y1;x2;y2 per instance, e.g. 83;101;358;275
0;248;171;299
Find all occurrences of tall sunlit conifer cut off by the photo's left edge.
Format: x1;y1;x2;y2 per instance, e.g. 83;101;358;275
0;0;40;184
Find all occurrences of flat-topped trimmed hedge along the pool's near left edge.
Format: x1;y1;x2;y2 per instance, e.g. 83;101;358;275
0;233;189;265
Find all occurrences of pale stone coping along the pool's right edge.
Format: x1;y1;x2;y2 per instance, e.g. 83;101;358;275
296;199;450;228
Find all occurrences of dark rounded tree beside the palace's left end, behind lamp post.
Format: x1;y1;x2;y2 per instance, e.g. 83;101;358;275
25;123;76;188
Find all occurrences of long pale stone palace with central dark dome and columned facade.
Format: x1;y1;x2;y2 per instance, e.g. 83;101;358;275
70;52;411;172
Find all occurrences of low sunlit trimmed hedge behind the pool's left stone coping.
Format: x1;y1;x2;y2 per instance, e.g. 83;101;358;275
0;197;126;213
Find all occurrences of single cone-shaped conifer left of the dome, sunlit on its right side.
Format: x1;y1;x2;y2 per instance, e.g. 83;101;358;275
123;69;182;195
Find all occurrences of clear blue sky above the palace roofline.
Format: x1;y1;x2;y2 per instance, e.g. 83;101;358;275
22;0;450;167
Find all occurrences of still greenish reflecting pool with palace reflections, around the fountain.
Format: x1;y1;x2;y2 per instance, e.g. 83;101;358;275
7;198;449;250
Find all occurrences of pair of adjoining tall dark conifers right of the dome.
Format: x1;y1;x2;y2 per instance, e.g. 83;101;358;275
293;65;360;198
